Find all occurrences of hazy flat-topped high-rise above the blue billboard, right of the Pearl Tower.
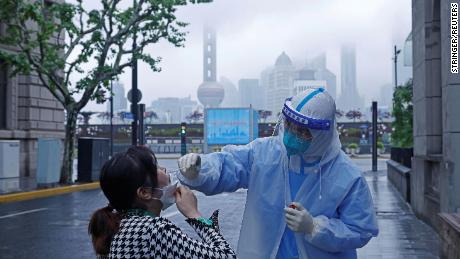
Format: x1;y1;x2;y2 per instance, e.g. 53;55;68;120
238;79;263;110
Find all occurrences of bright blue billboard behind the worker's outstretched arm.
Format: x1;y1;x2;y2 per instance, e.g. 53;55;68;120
205;108;257;145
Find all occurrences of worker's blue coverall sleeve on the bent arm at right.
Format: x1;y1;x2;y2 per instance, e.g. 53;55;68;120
305;177;378;252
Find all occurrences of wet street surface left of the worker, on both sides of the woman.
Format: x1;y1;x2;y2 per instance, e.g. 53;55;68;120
0;159;246;259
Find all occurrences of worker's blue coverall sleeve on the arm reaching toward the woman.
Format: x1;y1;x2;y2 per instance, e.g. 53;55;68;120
180;142;255;195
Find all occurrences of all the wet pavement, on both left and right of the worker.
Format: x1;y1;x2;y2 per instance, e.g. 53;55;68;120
0;159;439;259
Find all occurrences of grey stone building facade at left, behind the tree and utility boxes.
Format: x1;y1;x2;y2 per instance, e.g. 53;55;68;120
0;1;65;192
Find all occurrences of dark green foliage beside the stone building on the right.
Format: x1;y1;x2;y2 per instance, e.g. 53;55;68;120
392;80;413;148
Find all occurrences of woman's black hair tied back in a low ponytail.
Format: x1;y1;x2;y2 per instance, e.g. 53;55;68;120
88;146;158;255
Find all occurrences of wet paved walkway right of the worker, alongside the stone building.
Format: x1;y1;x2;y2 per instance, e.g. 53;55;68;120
355;170;439;259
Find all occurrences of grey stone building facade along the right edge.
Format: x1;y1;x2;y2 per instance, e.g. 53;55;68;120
411;0;460;258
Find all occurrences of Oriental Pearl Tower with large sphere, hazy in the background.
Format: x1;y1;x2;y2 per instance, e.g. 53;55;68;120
198;25;225;108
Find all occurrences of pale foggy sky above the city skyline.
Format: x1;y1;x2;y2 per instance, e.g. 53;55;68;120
80;0;411;111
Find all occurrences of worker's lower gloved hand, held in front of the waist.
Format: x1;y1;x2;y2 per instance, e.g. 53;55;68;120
284;202;314;234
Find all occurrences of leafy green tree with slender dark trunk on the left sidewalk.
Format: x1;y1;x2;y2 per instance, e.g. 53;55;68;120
0;0;211;183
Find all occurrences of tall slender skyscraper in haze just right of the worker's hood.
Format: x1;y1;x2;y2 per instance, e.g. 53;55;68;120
337;45;364;110
